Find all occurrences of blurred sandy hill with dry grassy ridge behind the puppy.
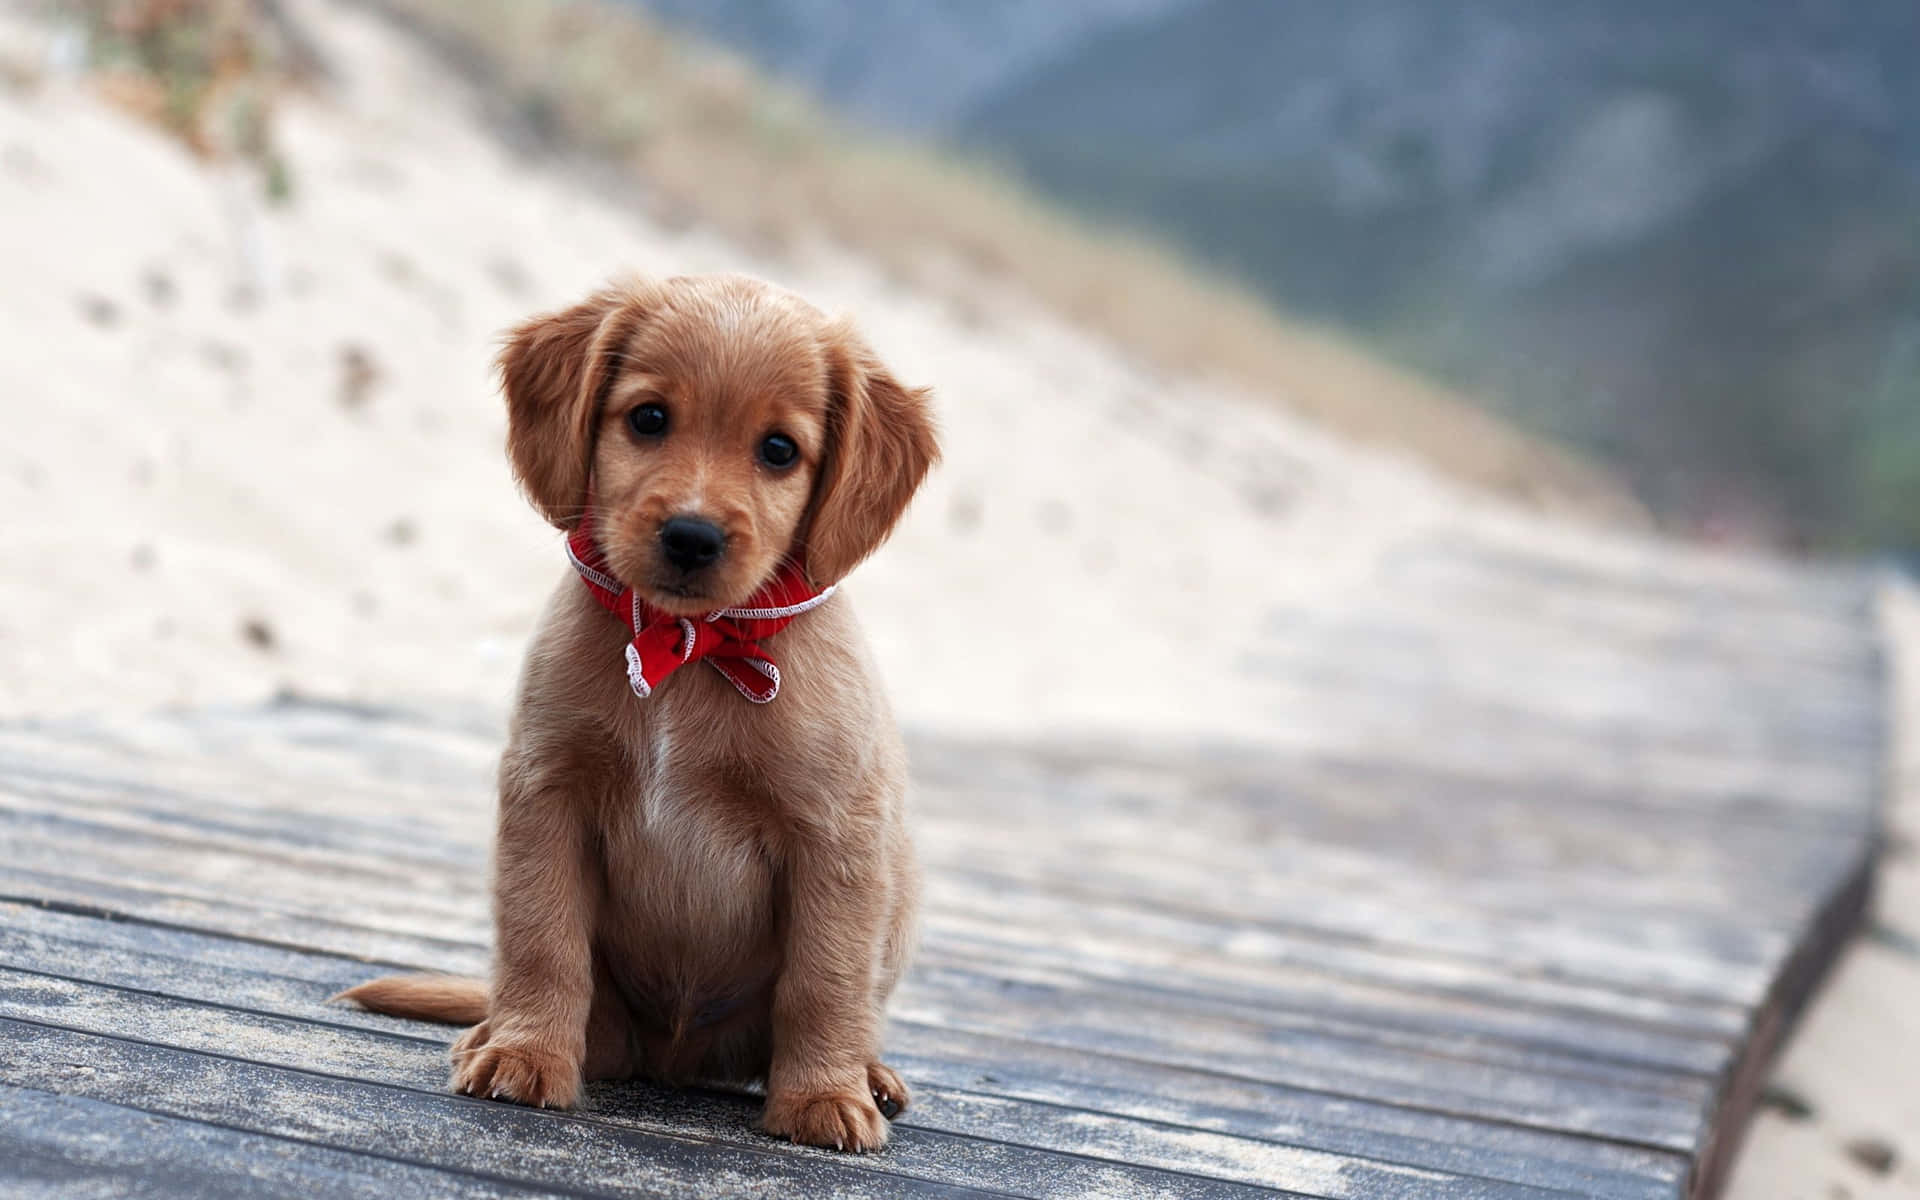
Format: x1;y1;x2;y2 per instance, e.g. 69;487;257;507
0;0;1835;737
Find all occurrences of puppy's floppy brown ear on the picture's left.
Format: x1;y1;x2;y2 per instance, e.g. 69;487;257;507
499;286;645;530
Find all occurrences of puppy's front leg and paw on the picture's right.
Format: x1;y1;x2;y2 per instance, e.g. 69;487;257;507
760;829;906;1152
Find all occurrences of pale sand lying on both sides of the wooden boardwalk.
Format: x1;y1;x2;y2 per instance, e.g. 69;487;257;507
0;0;1920;1198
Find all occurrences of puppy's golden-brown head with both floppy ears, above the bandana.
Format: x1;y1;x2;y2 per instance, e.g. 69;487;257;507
499;275;939;614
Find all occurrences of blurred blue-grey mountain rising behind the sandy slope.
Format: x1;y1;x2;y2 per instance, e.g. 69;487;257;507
633;0;1920;543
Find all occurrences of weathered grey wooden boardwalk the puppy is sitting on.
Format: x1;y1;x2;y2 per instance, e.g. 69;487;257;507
0;540;1884;1200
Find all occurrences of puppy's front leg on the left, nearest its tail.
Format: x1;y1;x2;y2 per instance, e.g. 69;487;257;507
453;764;595;1108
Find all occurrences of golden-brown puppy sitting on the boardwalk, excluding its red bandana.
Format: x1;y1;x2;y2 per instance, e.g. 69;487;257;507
344;276;939;1150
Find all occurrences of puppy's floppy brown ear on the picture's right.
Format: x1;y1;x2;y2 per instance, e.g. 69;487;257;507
806;321;941;586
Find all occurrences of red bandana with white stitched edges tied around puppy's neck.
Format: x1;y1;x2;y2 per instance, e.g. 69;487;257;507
566;513;833;705
